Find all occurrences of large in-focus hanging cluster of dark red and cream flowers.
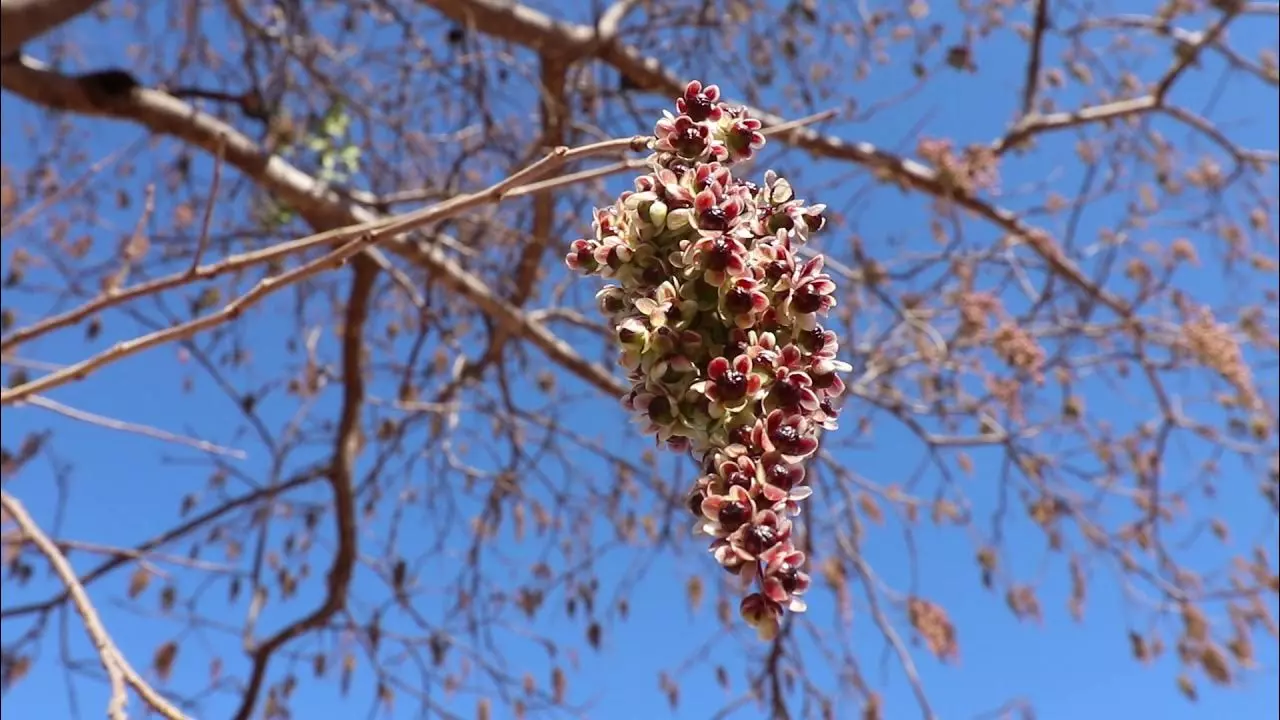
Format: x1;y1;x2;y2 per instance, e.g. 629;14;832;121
566;81;850;638
